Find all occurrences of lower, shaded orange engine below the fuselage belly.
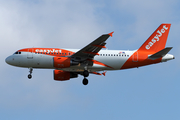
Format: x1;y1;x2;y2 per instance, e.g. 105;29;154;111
54;70;78;81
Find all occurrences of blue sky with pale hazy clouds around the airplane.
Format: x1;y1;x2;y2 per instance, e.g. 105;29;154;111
0;0;180;120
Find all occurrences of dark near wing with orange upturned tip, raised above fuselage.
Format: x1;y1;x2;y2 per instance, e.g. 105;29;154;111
71;32;114;62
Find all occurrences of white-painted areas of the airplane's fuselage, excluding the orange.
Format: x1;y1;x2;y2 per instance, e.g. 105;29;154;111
6;49;174;72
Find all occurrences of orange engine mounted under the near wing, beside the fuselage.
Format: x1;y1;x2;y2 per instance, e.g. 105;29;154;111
54;57;79;68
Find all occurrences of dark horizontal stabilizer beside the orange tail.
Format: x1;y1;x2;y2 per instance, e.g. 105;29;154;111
148;47;172;60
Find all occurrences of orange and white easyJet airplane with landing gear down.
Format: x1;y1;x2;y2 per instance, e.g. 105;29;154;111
5;24;175;85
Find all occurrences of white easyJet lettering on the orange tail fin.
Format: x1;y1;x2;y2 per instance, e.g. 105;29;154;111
145;25;168;50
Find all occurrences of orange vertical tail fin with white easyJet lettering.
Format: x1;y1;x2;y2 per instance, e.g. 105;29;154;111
139;24;171;52
